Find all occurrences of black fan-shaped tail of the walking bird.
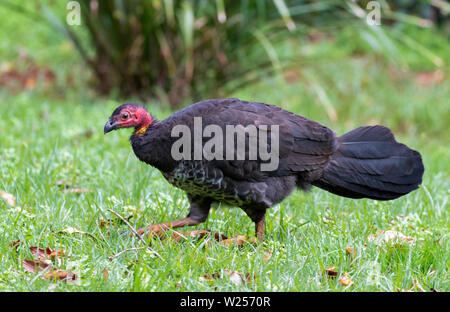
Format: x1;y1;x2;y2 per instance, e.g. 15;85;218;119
312;126;424;200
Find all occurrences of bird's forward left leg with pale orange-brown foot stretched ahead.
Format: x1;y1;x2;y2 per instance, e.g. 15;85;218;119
137;195;211;236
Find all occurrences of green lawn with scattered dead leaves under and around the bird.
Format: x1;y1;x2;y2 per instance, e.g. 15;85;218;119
0;5;450;291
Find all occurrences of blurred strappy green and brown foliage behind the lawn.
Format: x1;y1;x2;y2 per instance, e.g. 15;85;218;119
3;0;449;108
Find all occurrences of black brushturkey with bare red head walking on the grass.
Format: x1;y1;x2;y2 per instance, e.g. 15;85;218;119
104;98;424;242
